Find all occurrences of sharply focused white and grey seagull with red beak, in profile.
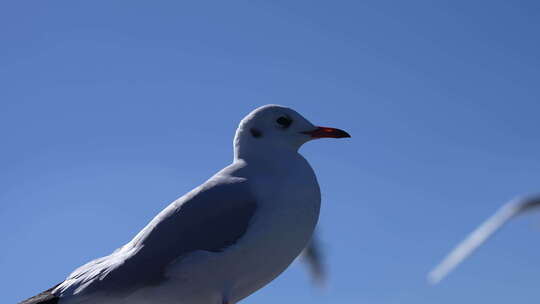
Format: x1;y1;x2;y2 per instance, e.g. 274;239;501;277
20;105;350;304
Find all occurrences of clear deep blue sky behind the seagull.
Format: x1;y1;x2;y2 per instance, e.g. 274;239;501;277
0;1;540;304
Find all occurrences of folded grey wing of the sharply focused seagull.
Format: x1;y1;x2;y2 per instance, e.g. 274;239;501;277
55;176;257;295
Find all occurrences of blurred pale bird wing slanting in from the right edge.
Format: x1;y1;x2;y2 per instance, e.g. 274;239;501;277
428;194;540;284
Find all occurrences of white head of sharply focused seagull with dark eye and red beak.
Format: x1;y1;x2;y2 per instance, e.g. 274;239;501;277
234;105;351;158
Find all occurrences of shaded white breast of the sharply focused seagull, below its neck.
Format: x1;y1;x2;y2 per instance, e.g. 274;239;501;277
227;155;321;301
